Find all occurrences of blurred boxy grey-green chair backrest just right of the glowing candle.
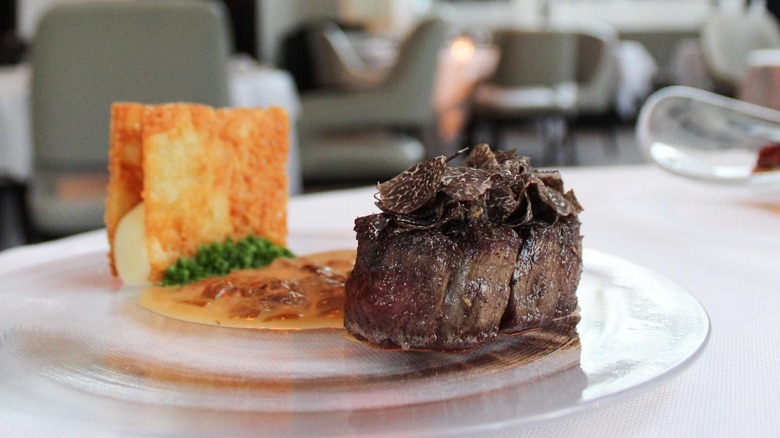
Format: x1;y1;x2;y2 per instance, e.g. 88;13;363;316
486;28;577;87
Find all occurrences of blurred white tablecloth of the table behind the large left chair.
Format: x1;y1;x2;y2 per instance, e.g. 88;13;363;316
0;58;302;193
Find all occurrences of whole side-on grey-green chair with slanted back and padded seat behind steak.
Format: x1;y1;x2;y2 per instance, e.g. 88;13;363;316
298;18;448;182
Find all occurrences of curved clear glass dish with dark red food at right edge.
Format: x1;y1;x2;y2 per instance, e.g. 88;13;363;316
636;87;780;186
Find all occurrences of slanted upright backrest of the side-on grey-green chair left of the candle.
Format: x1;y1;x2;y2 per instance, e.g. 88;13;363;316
382;17;449;121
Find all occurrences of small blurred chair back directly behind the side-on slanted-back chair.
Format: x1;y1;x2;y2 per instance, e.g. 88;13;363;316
308;20;384;90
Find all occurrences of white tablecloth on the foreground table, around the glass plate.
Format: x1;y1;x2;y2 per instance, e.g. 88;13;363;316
0;166;780;438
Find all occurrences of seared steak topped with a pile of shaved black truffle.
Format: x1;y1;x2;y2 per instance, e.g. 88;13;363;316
344;145;582;350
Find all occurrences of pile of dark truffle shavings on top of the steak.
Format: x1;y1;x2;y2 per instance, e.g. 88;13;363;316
376;144;582;233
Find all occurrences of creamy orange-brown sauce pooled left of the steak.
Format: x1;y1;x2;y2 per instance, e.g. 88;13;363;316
139;250;356;330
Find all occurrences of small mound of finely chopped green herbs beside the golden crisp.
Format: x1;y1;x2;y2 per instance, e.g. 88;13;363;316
162;236;293;286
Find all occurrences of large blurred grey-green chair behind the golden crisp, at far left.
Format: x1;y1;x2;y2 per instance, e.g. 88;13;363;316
28;0;230;237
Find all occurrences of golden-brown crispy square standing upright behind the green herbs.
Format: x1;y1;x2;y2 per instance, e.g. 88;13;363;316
106;103;289;281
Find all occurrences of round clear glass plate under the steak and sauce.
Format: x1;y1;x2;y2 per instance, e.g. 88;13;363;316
0;251;709;436
